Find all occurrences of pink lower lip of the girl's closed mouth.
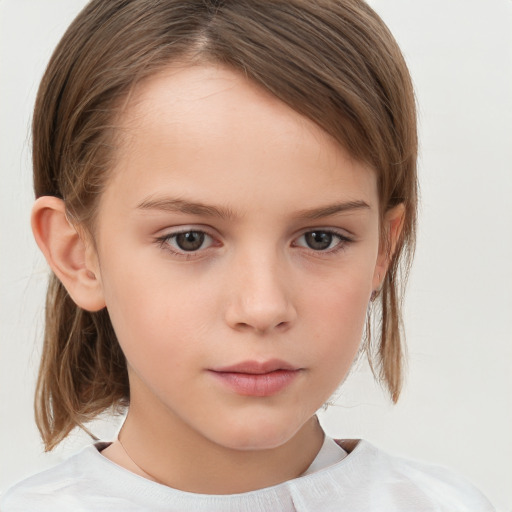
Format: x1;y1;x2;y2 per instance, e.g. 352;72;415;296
211;370;299;396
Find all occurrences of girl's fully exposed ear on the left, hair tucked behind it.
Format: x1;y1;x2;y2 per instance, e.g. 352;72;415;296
31;196;105;311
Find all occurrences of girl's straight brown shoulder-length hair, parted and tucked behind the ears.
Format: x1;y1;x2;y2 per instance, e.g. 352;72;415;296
33;0;417;450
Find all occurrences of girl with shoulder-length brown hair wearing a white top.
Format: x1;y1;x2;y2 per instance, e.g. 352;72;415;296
0;0;491;512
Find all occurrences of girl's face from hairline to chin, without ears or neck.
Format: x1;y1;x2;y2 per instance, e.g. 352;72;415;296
88;65;385;449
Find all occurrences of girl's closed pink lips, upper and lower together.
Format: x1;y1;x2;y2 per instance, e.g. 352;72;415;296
209;359;302;397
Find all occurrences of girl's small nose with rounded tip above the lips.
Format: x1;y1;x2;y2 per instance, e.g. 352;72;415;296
226;250;297;334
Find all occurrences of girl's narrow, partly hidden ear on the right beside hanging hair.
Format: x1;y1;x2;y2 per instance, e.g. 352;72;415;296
372;204;405;290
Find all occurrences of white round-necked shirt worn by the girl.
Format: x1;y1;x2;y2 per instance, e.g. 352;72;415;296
0;438;494;512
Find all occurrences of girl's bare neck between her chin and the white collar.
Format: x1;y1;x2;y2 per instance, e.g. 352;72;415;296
103;388;324;494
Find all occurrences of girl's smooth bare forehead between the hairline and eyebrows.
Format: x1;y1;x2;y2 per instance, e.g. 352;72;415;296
103;65;377;216
